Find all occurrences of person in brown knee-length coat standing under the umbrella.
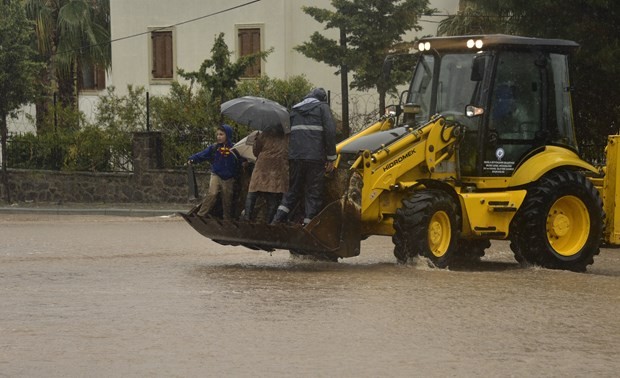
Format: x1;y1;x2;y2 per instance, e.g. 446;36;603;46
241;128;289;223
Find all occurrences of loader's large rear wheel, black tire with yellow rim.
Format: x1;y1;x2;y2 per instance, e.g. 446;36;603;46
510;169;605;272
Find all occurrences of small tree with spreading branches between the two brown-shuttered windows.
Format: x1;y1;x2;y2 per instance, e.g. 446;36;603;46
178;33;273;118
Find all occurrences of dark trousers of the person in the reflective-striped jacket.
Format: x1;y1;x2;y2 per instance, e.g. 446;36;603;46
278;160;325;223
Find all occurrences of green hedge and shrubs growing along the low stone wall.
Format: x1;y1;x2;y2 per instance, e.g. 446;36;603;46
7;76;312;172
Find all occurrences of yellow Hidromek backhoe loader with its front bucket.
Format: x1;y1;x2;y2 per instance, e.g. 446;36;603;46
183;35;620;271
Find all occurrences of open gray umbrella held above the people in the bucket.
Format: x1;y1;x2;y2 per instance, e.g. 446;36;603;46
220;96;291;133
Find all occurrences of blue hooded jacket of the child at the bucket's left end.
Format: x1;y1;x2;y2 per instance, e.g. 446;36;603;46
189;124;239;180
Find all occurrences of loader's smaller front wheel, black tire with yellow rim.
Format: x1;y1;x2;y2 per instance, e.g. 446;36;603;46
392;189;460;268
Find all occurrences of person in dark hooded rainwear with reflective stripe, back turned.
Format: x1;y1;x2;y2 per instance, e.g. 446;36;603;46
272;88;337;225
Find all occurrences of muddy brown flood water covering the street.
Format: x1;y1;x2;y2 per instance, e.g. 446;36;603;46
0;215;620;377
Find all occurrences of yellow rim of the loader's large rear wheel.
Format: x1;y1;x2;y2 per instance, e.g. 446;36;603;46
547;196;590;257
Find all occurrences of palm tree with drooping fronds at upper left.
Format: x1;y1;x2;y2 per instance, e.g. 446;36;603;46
25;0;112;131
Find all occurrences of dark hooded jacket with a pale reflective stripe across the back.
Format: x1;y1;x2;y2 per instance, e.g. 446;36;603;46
288;88;336;162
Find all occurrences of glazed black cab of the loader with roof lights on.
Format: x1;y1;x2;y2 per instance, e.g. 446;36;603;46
403;35;578;177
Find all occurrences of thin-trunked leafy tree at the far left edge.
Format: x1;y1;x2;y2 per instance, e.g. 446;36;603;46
0;0;39;202
